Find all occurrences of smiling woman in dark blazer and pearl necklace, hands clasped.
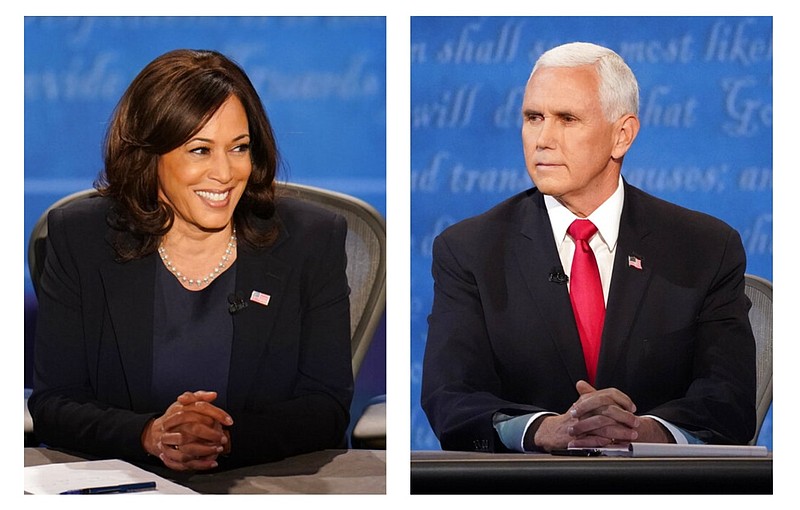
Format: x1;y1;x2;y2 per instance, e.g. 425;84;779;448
29;50;353;470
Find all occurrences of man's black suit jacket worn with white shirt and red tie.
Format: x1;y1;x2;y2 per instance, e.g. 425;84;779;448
422;184;755;451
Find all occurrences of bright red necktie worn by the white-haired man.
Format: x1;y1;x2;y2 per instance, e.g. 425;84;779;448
567;220;606;385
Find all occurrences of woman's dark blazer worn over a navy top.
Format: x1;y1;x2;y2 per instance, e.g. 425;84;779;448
29;193;353;467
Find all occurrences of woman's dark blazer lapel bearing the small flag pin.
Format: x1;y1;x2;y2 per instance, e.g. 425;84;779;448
228;239;291;409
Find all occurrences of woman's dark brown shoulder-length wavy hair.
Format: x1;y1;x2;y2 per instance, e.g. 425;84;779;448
95;50;280;260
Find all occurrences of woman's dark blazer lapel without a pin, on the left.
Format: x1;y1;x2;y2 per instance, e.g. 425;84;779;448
100;255;157;409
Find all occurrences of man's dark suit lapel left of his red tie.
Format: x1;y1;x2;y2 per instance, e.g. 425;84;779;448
513;191;587;381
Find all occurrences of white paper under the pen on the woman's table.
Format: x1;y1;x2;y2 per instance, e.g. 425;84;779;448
25;460;197;494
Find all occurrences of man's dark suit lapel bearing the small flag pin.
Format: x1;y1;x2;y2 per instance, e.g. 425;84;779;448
597;184;657;387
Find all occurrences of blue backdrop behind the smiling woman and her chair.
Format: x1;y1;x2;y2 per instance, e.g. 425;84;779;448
24;17;386;442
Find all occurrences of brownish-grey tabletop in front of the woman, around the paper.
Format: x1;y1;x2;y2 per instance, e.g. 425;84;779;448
25;448;386;494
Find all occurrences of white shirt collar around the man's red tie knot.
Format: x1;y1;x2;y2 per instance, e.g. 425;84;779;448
544;176;625;252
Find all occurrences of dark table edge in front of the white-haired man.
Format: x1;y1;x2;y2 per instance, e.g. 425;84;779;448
411;451;772;494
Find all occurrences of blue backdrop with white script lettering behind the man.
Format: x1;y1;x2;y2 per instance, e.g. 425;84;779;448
410;17;772;449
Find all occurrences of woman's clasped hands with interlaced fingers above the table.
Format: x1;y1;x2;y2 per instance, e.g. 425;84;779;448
142;391;233;471
